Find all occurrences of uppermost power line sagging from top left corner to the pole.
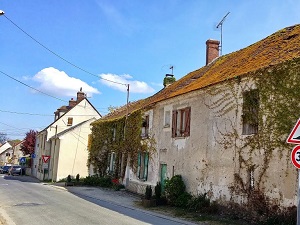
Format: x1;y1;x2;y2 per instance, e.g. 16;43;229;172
3;14;128;86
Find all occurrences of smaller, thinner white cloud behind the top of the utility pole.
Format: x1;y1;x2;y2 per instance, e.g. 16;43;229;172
100;73;155;94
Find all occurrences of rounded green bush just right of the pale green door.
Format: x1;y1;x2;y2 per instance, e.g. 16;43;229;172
165;175;185;205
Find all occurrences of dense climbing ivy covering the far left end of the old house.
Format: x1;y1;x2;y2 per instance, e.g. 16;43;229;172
88;110;156;178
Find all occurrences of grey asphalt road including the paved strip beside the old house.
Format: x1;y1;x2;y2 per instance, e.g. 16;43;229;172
0;175;199;225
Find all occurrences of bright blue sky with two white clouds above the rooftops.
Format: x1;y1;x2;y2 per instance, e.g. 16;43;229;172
0;0;300;140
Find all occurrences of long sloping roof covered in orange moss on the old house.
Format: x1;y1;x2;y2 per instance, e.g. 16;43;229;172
100;24;300;120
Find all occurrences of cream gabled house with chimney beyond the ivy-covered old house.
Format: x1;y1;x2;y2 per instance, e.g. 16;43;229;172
32;90;101;181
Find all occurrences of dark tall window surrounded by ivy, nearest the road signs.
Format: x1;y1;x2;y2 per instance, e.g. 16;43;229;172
242;89;259;135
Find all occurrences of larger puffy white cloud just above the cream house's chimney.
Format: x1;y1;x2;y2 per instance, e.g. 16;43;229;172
33;67;100;97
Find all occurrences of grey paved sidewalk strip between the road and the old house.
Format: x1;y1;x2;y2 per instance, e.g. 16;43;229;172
52;183;204;225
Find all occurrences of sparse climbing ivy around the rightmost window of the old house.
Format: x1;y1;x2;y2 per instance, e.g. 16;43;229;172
205;59;300;204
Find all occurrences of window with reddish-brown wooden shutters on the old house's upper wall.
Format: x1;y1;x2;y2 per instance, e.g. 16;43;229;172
172;107;191;137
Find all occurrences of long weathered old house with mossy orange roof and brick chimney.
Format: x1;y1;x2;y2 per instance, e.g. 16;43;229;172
92;25;300;207
